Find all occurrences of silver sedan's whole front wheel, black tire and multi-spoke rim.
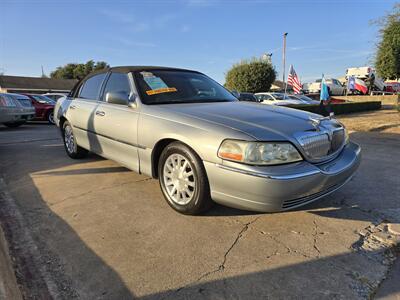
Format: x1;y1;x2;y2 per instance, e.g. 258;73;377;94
158;142;213;215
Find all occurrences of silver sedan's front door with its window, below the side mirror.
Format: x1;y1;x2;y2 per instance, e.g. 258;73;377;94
94;72;139;172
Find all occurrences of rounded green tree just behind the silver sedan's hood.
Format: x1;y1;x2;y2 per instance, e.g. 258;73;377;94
225;58;276;93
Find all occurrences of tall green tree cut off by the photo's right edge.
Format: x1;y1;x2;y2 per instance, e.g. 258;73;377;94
375;3;400;79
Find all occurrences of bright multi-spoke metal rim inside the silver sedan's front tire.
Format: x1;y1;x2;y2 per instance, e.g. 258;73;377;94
163;153;196;205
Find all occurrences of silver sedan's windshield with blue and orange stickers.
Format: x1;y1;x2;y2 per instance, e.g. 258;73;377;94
134;70;237;104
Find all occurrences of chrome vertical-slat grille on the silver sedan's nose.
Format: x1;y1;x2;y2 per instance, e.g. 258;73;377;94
298;133;331;159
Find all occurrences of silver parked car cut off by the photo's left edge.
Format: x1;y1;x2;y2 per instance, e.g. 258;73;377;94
0;93;35;127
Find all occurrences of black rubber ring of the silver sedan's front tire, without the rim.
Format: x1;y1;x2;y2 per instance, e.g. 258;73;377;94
158;142;211;215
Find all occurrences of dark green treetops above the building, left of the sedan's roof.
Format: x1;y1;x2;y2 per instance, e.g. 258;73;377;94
50;60;110;79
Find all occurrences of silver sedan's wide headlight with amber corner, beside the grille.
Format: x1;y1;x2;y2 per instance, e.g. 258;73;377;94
218;140;303;165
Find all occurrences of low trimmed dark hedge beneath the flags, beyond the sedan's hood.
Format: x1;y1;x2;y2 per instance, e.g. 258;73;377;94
287;101;382;115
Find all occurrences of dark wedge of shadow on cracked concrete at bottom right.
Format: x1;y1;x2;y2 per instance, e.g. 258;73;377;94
140;249;400;300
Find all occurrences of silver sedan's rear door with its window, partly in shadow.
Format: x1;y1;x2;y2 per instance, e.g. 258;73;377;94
67;73;107;153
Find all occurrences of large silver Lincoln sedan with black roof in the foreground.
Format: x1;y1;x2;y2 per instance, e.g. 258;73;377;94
55;67;361;214
